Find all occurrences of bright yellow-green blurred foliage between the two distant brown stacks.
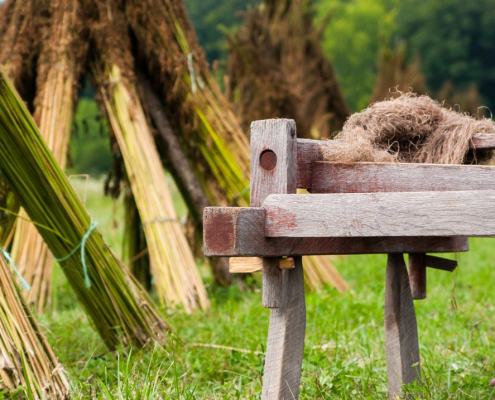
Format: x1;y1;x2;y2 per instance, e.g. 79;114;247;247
317;0;396;111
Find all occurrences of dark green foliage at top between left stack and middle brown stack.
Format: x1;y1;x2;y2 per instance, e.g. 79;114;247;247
184;0;259;62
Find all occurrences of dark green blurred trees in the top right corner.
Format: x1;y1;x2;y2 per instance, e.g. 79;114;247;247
398;0;495;107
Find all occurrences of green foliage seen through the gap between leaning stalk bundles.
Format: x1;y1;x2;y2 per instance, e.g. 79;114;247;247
69;97;112;176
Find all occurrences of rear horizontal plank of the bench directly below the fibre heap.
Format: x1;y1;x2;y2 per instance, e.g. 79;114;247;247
311;162;495;193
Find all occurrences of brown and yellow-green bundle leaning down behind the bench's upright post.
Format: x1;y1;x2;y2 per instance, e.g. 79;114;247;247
125;0;249;206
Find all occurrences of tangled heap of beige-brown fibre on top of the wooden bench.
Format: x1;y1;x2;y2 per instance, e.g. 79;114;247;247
324;93;495;164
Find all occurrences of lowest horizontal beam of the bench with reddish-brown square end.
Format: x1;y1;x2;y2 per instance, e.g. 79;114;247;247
203;207;469;257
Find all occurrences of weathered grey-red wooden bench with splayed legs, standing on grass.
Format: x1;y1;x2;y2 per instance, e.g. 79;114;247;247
204;119;495;400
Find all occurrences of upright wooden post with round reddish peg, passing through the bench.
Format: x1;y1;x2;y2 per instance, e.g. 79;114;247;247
251;119;297;308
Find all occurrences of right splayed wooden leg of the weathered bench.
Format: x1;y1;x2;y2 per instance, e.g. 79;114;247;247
385;254;421;399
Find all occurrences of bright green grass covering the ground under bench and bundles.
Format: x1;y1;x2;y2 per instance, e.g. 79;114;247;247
35;178;495;399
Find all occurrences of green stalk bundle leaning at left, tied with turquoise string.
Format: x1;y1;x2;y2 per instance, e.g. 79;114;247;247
0;72;167;347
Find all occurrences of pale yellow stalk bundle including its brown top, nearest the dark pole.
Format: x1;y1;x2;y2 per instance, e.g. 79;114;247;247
94;2;209;312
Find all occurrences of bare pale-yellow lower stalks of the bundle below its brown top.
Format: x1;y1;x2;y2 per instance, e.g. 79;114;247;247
98;65;209;312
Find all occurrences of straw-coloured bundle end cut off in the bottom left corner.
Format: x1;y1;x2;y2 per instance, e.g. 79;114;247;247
0;255;69;400
